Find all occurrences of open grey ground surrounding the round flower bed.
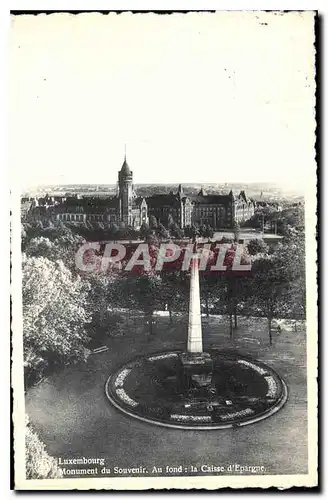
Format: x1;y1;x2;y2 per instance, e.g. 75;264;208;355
26;315;307;475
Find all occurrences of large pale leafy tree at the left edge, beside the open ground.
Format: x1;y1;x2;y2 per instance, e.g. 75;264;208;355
23;257;90;383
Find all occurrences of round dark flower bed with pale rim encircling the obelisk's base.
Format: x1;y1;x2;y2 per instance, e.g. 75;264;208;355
105;351;287;429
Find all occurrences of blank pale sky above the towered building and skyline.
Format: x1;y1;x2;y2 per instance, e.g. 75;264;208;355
9;12;316;191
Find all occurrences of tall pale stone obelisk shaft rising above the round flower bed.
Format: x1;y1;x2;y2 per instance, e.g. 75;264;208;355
187;257;203;354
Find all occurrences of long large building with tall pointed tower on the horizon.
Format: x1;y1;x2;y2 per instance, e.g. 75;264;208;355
25;157;254;229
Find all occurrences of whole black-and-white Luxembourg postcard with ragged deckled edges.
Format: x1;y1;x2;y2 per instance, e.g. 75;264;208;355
9;11;318;490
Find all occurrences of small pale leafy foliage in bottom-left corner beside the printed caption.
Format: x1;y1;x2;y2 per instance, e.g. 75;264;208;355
25;415;62;479
